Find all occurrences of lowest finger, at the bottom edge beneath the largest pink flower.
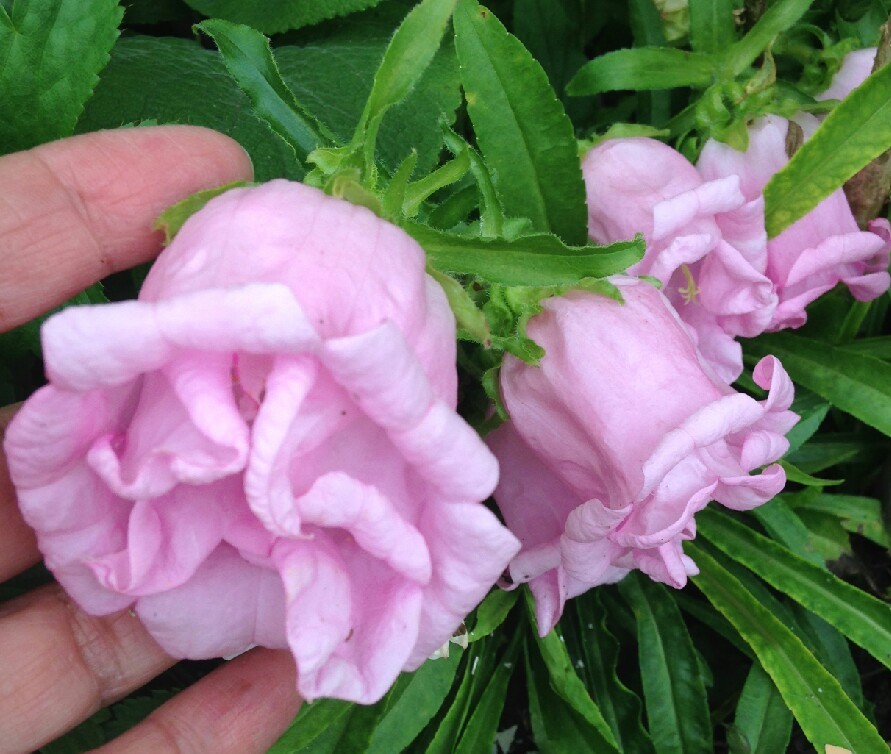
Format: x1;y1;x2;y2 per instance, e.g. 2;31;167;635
95;649;301;754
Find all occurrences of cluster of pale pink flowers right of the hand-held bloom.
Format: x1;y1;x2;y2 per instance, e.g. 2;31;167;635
488;51;891;633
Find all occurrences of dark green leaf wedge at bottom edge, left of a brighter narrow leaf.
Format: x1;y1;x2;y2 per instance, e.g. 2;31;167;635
524;641;620;754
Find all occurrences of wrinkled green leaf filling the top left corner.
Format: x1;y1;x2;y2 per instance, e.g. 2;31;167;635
0;0;124;152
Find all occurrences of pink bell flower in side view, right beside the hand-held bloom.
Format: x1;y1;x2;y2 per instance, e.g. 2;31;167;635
488;278;797;634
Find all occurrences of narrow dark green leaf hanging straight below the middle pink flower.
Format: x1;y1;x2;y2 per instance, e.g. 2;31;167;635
619;574;712;754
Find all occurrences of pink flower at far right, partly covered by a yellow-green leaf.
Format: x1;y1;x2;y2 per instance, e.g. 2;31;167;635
697;113;891;328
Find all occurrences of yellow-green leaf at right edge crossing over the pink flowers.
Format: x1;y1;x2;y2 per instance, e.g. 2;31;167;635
764;59;891;238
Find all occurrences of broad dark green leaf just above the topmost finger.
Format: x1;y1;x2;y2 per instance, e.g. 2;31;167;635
77;36;302;181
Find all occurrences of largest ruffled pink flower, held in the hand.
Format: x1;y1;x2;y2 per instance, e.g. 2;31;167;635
6;181;518;703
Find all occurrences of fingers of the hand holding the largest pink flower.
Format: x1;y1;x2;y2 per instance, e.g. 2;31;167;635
0;126;301;754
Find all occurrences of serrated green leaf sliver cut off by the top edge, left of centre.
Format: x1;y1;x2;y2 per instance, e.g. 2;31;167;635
185;0;381;34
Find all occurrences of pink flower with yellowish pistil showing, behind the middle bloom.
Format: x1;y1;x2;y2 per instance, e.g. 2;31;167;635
582;138;776;384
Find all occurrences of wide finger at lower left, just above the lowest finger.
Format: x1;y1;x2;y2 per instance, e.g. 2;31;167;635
0;585;174;754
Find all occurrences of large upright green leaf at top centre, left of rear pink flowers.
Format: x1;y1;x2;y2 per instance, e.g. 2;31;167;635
455;0;588;244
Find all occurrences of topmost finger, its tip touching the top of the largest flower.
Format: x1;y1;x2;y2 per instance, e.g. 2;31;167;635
0;126;252;331
